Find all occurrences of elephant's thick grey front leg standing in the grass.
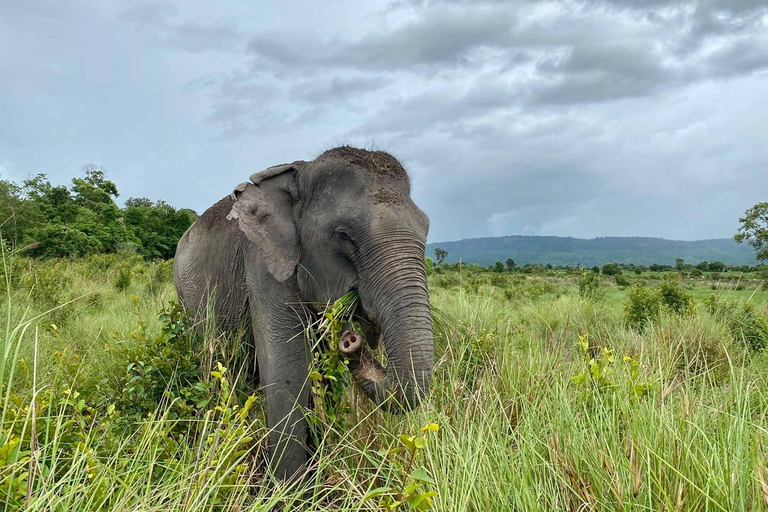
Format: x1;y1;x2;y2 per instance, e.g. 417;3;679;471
254;305;310;480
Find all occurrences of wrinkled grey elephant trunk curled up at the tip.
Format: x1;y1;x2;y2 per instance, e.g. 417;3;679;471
349;235;433;412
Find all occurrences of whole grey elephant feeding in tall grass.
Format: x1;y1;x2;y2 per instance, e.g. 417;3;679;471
173;146;433;480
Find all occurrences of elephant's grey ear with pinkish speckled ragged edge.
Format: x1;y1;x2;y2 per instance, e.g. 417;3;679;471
227;162;300;283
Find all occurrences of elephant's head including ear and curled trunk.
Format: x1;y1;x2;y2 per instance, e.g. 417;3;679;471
228;146;433;412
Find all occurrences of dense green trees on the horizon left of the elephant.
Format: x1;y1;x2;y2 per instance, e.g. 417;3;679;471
0;165;197;259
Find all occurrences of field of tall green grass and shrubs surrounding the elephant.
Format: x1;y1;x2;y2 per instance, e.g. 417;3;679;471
0;247;768;512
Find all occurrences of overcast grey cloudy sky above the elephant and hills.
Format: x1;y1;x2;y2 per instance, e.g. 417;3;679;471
0;0;768;241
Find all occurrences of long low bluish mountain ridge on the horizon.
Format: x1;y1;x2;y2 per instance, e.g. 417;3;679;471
427;235;757;267
